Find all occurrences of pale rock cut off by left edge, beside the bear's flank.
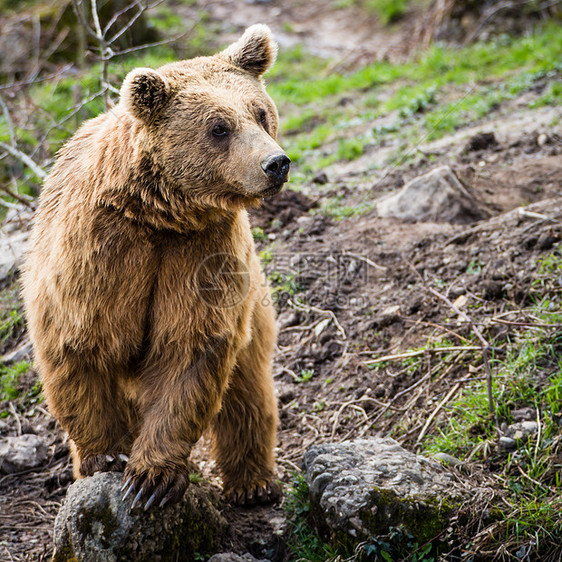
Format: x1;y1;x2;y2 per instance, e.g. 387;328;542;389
0;209;32;281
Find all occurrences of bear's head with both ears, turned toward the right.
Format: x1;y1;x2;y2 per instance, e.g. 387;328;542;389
120;25;290;209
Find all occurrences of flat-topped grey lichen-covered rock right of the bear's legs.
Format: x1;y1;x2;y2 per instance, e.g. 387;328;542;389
304;437;467;542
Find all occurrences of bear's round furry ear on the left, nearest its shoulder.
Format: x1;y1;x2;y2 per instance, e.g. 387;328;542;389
121;68;170;121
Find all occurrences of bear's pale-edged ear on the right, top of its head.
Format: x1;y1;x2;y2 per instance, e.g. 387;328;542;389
219;24;277;78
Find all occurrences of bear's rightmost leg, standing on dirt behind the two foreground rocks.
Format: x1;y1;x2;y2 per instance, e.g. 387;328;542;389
213;303;281;505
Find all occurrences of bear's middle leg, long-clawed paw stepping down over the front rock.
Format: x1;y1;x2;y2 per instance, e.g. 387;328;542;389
123;336;236;509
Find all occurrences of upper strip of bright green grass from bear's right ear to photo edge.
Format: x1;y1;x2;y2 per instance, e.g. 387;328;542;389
268;24;562;105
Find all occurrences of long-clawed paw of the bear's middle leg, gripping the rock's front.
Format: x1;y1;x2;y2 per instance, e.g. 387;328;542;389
121;465;189;511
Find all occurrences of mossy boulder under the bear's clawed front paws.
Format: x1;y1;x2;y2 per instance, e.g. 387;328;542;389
53;472;226;562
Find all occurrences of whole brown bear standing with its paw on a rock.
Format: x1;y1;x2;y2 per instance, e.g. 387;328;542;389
22;25;290;508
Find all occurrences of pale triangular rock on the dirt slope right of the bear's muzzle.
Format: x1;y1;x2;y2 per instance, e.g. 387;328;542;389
377;166;488;224
